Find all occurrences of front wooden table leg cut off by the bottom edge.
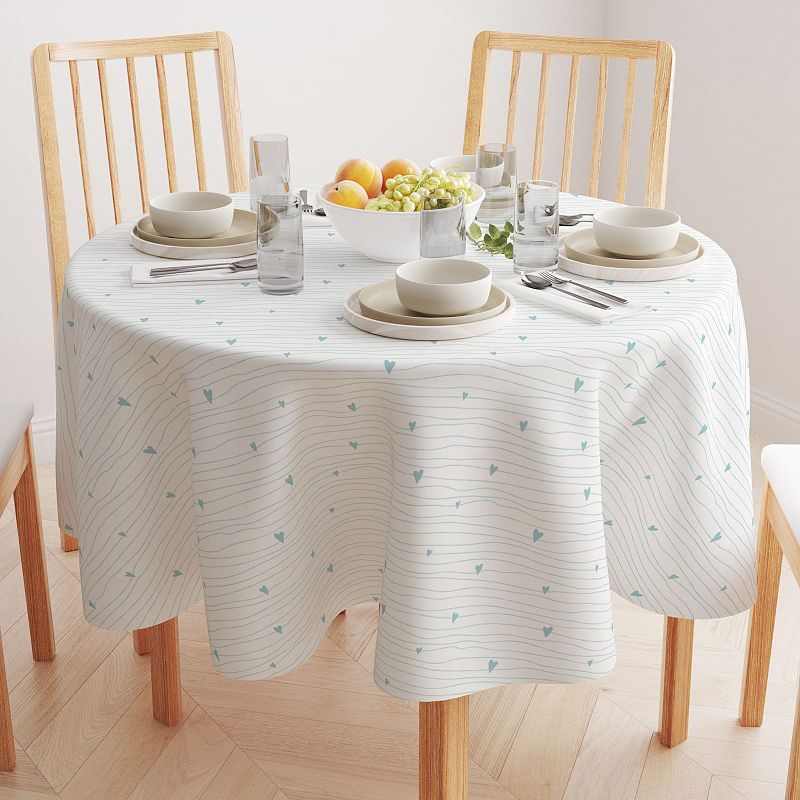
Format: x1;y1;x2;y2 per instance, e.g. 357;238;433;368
419;695;469;800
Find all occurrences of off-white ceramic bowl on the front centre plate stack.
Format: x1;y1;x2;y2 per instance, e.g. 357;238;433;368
394;258;492;317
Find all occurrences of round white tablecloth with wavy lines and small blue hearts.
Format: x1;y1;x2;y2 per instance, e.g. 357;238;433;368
57;197;755;700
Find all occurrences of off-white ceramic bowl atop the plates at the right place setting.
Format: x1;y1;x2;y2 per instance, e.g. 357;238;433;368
594;206;681;258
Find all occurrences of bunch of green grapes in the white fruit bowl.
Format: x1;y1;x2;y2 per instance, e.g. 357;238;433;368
366;167;475;212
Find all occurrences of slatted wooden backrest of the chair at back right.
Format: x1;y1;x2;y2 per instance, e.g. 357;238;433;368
464;31;674;206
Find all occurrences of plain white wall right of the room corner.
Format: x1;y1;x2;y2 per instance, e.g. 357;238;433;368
606;0;800;442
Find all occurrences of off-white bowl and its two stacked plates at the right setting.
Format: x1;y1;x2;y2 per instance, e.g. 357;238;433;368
558;206;705;281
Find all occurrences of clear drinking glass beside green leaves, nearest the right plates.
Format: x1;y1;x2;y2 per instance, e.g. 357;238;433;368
514;181;558;272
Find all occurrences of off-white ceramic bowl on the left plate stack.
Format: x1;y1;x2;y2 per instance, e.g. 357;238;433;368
150;192;233;239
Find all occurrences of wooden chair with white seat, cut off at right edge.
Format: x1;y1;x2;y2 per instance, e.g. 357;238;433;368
739;444;800;800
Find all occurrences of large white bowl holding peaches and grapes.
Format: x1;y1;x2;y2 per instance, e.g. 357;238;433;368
319;186;485;264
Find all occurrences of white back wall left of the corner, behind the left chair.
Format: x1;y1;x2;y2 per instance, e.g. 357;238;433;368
0;0;604;460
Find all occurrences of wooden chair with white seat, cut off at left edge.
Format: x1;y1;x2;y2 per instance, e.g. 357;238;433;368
0;400;56;770
